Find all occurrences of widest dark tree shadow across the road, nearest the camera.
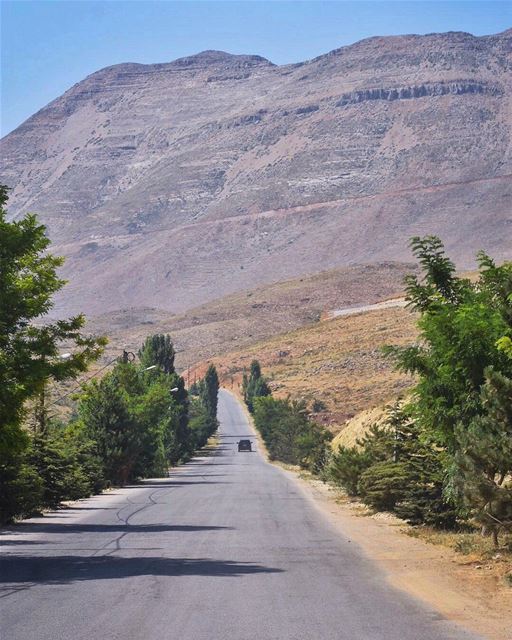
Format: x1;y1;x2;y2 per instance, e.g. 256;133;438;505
0;556;282;589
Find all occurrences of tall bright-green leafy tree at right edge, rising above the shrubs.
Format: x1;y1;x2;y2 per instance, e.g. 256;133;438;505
387;236;512;453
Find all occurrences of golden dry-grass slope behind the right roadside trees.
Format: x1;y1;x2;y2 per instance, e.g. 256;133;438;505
209;308;417;432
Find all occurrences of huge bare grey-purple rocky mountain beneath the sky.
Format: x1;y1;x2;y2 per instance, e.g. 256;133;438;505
0;30;512;313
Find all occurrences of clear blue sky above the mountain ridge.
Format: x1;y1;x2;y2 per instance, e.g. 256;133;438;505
1;0;512;135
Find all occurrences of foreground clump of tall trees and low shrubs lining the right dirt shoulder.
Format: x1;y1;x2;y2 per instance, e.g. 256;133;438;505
329;236;512;546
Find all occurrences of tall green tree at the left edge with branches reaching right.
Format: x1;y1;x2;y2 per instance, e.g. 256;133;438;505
0;186;106;521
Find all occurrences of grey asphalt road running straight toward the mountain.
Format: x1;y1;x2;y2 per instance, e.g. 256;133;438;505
0;392;475;640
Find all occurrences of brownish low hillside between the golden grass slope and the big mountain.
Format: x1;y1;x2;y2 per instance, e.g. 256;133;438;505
87;263;414;371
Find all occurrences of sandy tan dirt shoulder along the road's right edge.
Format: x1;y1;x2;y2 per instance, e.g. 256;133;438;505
284;469;512;640
